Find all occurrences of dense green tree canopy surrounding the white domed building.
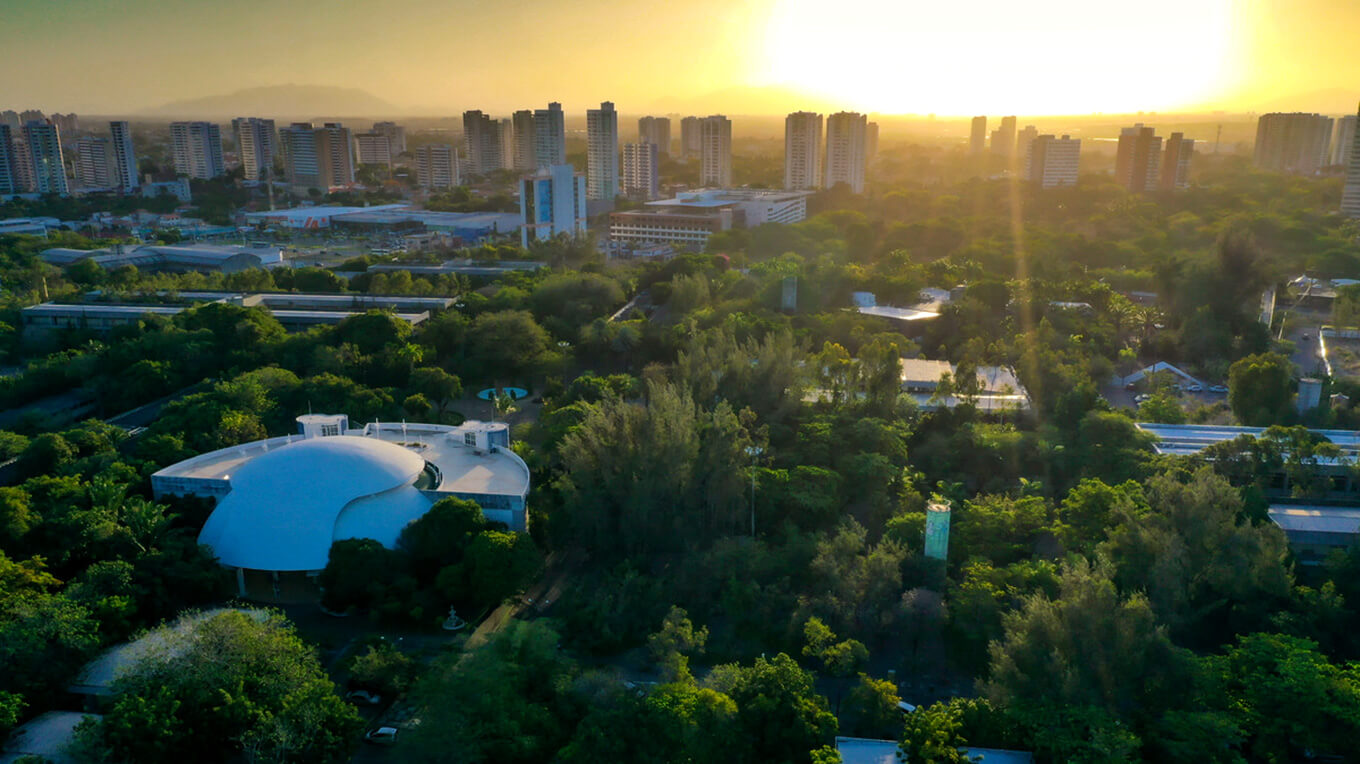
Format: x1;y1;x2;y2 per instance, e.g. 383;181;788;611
0;147;1360;764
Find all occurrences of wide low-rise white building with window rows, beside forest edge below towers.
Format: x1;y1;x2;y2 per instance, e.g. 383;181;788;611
609;189;812;250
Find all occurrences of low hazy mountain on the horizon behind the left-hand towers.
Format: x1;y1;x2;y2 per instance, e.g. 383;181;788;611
143;84;401;120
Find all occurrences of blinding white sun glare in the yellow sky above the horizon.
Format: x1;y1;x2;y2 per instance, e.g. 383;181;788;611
751;0;1235;116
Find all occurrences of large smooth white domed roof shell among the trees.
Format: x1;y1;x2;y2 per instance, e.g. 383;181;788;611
199;435;430;571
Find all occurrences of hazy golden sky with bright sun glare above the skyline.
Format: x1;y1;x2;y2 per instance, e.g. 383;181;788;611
0;0;1360;116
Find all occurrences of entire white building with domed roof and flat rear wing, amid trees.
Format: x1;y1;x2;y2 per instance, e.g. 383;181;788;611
151;415;529;595
